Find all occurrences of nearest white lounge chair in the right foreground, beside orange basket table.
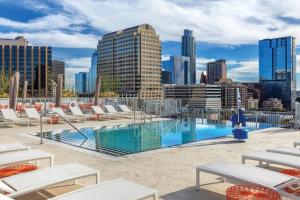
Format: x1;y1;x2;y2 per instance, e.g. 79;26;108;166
196;161;300;200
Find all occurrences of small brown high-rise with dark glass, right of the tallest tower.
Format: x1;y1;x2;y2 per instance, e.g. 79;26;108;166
206;60;227;84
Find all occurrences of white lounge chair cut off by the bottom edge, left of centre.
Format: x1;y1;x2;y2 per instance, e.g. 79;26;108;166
51;179;158;200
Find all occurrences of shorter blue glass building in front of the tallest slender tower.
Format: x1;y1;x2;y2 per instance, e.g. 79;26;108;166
162;56;192;85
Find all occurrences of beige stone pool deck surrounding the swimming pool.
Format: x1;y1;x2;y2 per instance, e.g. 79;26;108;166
0;119;300;200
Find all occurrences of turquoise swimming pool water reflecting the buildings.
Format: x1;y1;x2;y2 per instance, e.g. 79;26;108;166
45;119;271;155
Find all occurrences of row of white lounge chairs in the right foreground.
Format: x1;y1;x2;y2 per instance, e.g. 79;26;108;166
196;141;300;200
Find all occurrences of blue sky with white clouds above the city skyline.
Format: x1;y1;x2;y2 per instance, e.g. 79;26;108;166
0;0;300;89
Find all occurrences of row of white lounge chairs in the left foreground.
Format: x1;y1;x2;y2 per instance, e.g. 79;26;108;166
0;143;158;200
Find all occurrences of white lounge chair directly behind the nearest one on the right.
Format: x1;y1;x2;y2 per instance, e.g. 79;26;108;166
242;151;300;168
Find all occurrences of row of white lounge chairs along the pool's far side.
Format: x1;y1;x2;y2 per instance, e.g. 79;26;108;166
0;105;138;127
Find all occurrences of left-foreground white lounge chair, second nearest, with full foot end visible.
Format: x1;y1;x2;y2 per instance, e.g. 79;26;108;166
0;163;99;198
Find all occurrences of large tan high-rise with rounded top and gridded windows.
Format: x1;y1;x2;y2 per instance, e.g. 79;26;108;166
97;24;162;98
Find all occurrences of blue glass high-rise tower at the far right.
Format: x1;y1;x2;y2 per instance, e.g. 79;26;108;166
259;37;296;110
